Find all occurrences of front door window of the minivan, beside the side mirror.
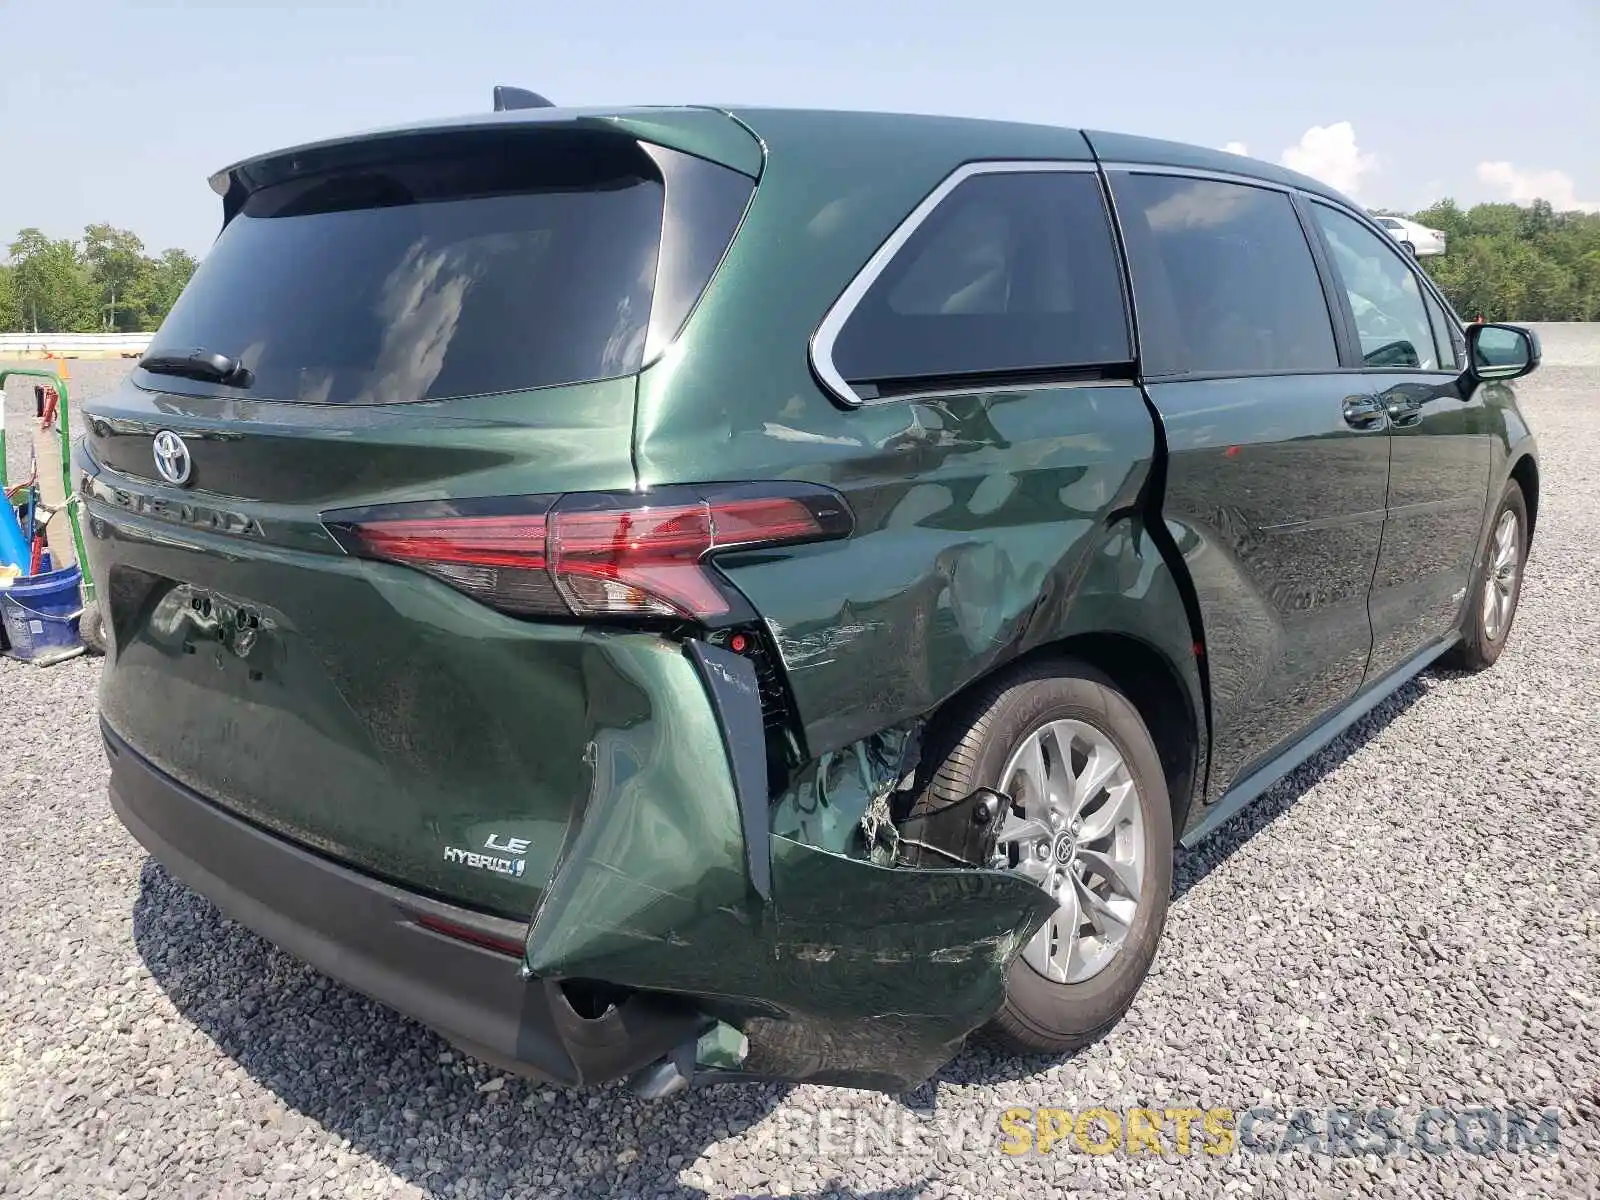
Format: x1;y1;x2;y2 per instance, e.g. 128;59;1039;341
1312;205;1440;371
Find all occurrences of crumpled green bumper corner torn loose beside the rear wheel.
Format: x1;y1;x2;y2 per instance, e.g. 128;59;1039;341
525;637;1054;1091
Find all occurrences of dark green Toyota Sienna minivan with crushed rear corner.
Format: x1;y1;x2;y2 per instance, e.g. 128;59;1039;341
77;107;1539;1094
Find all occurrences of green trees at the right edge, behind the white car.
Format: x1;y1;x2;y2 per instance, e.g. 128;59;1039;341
1411;200;1600;322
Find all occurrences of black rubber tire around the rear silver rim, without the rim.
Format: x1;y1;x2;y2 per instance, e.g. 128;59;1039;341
914;661;1173;1054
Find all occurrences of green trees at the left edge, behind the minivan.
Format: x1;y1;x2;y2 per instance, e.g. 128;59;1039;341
0;224;195;333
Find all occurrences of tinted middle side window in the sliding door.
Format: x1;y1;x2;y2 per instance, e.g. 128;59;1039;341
1112;173;1339;374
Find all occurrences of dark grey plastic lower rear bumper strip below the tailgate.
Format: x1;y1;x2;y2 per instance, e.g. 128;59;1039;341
106;730;706;1083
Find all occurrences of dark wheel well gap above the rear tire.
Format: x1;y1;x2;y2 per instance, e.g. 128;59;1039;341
941;634;1200;838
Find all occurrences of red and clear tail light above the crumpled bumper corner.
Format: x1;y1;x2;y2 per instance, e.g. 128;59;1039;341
325;485;854;622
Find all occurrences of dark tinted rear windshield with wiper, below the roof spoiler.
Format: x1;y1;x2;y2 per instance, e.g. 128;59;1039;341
144;131;752;405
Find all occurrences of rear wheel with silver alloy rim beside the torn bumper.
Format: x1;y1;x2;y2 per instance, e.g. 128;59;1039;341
918;662;1173;1053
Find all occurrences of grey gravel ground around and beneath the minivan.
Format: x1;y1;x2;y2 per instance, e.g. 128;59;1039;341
0;326;1600;1197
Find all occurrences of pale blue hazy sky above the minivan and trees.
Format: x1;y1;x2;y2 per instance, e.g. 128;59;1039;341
0;0;1600;254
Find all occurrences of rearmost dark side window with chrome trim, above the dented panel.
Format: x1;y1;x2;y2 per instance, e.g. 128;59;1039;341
834;171;1133;384
